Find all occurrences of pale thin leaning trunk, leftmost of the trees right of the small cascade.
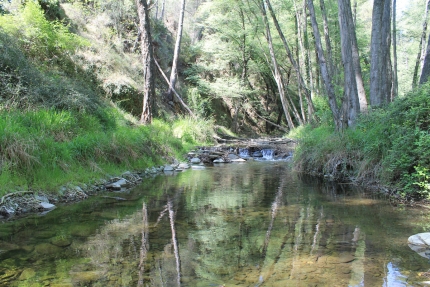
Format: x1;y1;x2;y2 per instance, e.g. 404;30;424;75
261;0;294;130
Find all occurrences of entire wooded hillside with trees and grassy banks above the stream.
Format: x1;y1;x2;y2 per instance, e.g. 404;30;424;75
0;0;430;199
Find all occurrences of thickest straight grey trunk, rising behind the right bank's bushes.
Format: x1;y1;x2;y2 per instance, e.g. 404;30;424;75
370;0;391;107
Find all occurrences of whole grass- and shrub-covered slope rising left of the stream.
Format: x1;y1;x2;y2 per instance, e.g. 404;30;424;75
0;1;218;196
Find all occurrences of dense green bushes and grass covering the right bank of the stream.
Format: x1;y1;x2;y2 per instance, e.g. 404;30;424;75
295;84;430;199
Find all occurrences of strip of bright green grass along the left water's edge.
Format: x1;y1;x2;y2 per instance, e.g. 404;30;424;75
0;108;213;196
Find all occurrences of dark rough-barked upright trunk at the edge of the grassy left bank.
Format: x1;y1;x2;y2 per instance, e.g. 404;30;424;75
136;0;155;124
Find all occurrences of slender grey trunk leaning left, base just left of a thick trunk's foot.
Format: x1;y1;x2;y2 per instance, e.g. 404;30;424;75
307;0;340;130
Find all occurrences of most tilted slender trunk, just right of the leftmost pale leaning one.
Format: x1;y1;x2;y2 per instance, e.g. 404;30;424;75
265;0;315;122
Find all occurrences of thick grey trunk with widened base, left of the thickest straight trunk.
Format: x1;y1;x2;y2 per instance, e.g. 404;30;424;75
337;0;360;127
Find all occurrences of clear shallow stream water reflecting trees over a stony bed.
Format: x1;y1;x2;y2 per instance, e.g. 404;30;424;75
0;162;430;287
